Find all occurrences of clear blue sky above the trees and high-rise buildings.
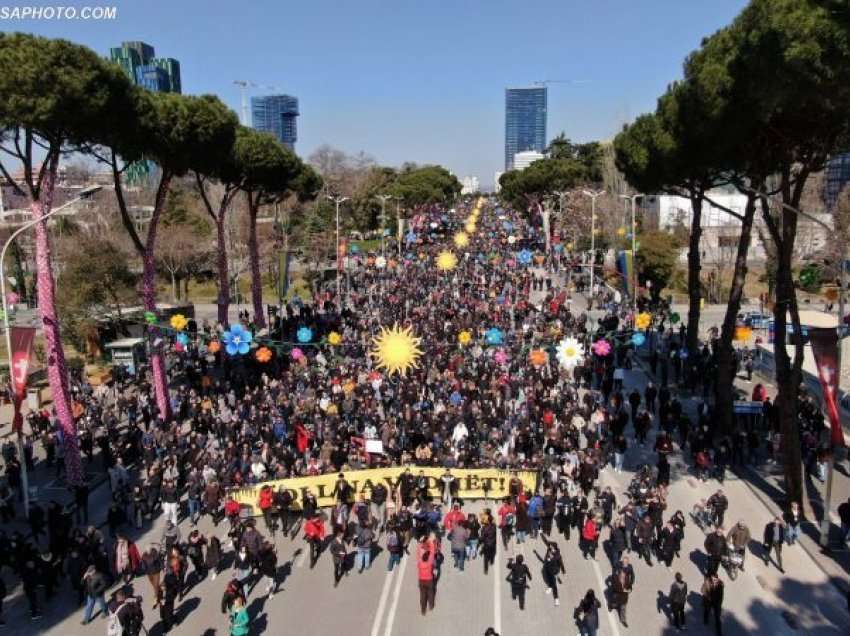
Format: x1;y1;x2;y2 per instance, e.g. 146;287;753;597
9;0;745;185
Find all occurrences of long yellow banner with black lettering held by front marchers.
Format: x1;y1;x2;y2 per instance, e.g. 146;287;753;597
230;466;537;515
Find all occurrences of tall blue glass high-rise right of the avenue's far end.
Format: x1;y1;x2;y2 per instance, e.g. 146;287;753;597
505;86;548;170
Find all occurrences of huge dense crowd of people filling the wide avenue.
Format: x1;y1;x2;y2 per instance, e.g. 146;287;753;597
0;200;850;636
